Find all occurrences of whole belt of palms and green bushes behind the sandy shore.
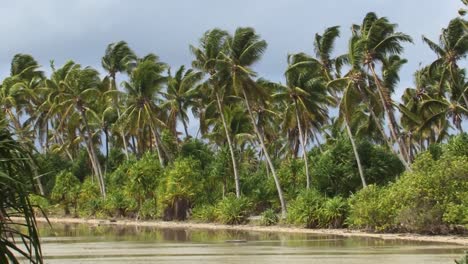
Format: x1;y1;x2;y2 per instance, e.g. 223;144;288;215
0;1;468;263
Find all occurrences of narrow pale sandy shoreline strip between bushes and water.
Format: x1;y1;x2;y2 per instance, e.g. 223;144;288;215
26;217;468;246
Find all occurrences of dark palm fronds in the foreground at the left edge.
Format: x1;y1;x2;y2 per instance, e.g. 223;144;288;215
0;122;43;263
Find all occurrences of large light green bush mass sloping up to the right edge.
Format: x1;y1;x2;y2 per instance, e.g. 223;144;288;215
348;135;468;233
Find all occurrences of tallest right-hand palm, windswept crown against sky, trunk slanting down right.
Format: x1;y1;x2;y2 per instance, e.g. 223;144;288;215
352;12;412;165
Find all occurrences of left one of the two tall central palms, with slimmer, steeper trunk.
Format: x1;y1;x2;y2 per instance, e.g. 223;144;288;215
190;29;241;198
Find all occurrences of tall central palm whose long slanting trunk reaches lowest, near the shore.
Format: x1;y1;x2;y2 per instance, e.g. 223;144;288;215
222;28;286;217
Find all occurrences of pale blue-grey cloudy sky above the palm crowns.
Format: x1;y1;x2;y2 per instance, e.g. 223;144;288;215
0;0;467;134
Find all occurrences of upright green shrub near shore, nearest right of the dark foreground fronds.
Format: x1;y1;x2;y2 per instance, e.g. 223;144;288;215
51;171;80;215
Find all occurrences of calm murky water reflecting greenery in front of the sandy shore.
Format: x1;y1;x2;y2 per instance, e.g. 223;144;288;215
32;224;463;264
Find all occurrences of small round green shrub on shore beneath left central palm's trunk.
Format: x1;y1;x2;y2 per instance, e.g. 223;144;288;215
216;195;252;225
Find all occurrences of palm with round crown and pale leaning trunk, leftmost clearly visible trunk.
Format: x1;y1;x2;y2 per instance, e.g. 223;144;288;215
46;61;106;197
